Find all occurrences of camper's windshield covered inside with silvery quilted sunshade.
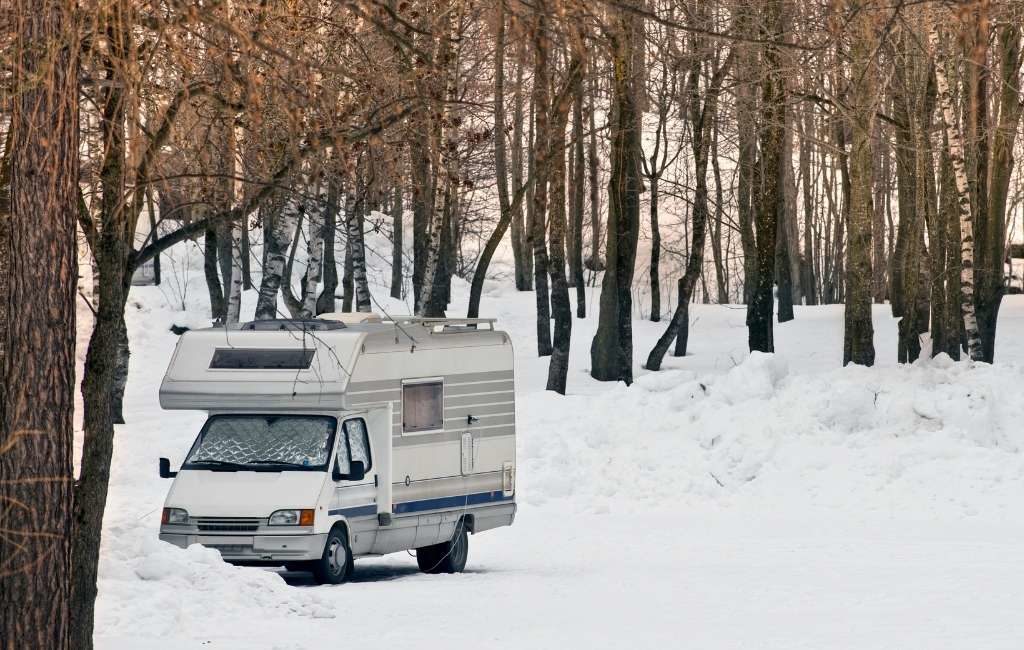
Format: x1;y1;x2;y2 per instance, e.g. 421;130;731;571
183;415;337;471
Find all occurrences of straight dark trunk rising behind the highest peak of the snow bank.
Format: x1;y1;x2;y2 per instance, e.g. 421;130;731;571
746;0;785;352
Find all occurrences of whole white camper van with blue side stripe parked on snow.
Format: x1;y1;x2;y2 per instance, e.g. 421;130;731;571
160;314;516;583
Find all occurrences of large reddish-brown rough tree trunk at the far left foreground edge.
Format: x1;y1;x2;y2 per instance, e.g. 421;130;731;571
0;0;77;650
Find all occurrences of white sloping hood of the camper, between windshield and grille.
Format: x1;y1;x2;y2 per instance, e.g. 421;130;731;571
164;470;328;517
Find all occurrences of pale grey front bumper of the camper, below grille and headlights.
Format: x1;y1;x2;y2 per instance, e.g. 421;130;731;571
160;531;327;562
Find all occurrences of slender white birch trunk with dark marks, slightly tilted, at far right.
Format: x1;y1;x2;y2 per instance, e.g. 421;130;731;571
928;20;983;361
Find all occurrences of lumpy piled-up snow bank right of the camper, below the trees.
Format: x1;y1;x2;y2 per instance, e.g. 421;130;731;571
519;353;1024;517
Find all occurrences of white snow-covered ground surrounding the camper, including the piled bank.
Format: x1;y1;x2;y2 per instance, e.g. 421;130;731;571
82;240;1024;649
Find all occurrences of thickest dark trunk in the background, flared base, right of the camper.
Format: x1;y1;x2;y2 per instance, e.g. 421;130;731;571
590;0;644;384
